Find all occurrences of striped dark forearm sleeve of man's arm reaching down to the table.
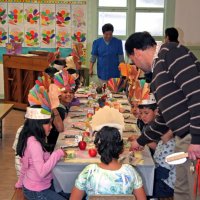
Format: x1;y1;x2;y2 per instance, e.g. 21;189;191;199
137;112;169;146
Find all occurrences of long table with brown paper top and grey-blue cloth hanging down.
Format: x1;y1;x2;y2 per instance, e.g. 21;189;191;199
53;96;155;195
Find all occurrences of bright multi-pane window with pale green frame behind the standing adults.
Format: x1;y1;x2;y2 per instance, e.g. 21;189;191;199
97;0;166;56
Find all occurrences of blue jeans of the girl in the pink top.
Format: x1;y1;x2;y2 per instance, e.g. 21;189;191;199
23;187;66;200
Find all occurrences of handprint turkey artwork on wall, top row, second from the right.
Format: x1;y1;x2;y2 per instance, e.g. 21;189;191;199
56;4;71;27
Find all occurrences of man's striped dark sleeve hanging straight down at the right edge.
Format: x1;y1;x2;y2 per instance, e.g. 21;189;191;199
166;46;200;144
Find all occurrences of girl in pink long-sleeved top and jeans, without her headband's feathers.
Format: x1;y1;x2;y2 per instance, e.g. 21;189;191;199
15;107;65;200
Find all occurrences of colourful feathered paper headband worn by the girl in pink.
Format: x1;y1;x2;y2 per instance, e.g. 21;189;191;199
25;75;51;120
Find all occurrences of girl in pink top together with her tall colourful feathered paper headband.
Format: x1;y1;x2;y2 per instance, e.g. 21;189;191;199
15;82;65;200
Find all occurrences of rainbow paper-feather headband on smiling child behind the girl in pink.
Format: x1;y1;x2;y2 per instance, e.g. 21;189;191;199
54;69;76;91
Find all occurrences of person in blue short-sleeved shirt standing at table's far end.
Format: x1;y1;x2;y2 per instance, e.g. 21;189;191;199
89;24;124;83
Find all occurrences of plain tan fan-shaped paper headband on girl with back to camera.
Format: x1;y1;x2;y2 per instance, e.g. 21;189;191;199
91;106;124;135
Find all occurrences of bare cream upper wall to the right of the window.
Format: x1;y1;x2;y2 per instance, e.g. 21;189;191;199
175;0;200;46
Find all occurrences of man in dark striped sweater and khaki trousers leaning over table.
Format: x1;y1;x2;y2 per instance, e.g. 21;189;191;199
125;32;200;200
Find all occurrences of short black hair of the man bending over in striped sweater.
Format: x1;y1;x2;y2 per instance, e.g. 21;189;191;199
125;31;157;55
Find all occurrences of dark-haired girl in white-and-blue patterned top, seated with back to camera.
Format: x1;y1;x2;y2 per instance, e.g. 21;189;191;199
70;126;146;200
